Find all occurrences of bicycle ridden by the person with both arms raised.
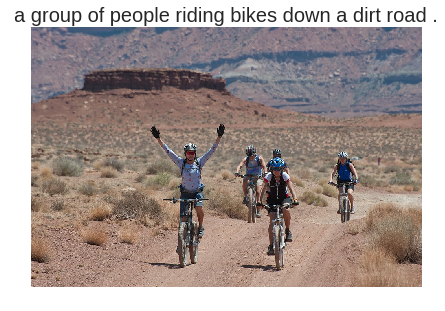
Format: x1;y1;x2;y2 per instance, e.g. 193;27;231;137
164;197;208;268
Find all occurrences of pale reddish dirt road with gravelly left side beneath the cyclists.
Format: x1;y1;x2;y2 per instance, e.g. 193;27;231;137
31;190;422;287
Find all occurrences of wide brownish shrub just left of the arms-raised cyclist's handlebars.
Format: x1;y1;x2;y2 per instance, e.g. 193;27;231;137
109;191;165;224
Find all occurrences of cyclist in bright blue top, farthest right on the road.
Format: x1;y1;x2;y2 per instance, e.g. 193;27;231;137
329;151;358;214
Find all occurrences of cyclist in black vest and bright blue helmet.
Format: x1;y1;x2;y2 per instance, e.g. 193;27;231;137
260;157;298;255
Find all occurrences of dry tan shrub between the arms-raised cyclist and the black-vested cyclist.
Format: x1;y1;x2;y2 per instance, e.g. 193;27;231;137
206;188;247;219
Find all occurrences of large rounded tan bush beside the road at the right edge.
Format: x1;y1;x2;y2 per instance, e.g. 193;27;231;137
366;204;422;263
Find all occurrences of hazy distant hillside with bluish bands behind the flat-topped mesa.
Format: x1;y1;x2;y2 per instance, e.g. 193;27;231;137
31;28;422;117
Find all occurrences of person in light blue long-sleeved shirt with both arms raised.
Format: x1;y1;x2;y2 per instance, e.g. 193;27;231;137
151;124;225;238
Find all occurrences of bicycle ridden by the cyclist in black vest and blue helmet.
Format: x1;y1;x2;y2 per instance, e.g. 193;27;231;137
264;202;299;270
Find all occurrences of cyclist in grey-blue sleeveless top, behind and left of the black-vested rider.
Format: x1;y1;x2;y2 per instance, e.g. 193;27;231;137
235;145;267;208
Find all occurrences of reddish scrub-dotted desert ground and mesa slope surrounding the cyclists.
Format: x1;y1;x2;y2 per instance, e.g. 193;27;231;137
31;70;422;287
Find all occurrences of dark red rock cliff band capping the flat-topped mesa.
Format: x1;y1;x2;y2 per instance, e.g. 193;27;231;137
83;69;226;92
